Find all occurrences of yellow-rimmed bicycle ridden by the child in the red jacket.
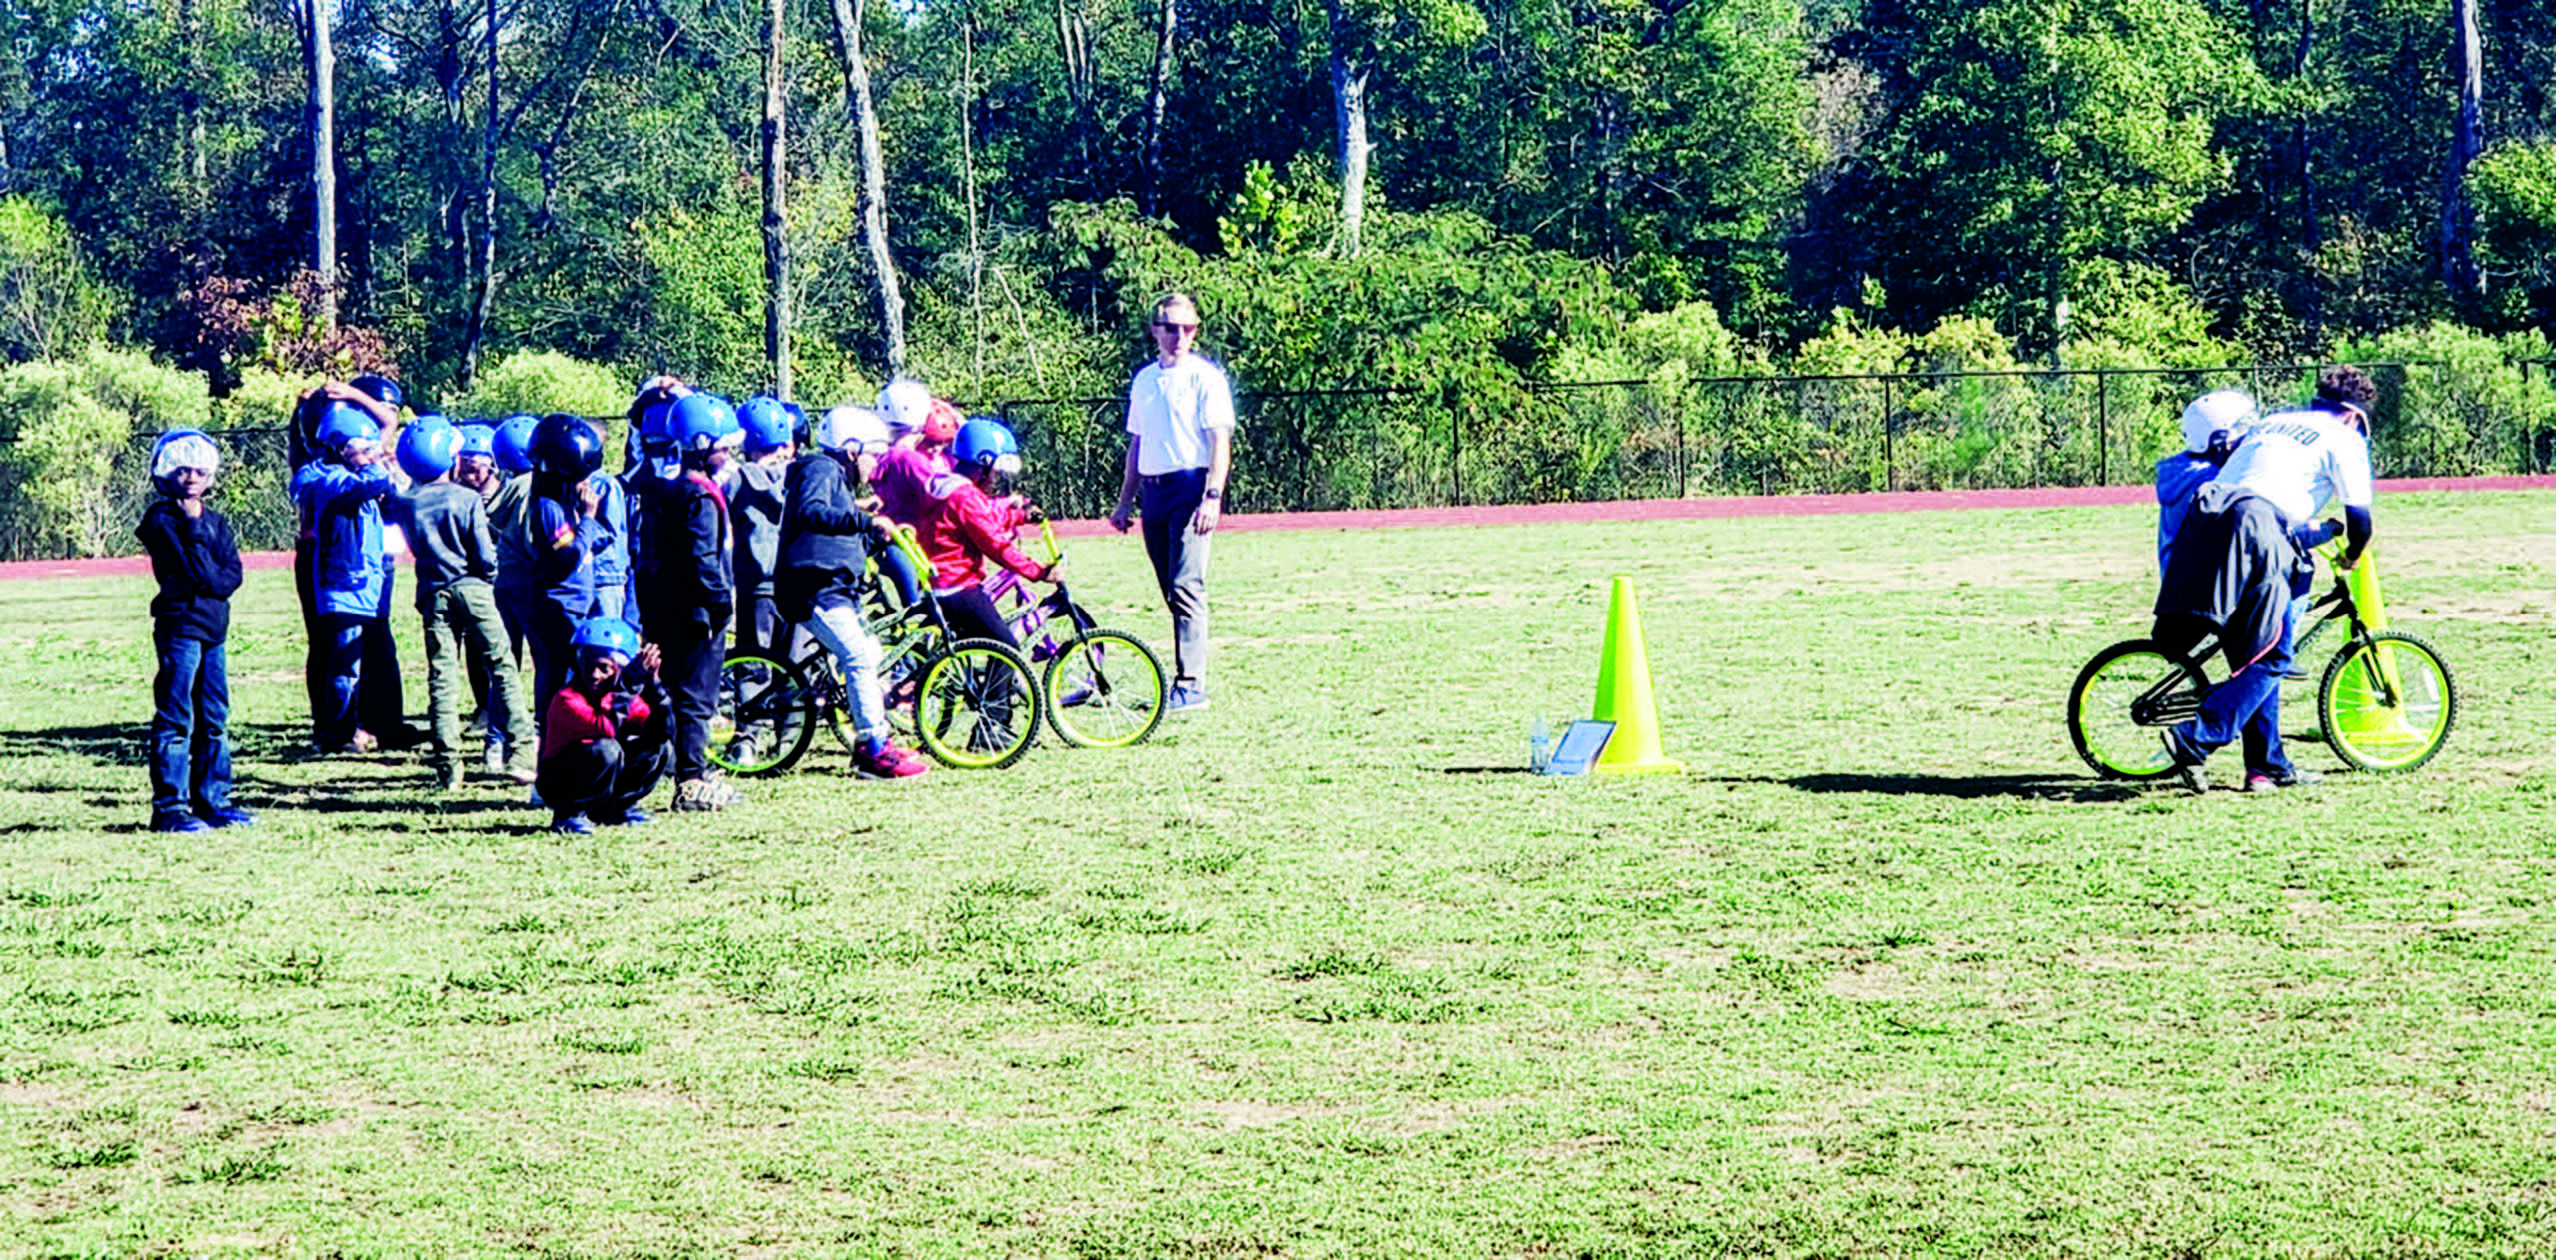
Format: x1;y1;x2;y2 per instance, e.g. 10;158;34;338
984;511;1171;749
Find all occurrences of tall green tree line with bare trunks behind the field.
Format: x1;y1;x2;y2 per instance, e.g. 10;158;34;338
0;0;2556;465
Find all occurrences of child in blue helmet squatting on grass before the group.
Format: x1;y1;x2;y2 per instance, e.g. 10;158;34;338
539;616;667;836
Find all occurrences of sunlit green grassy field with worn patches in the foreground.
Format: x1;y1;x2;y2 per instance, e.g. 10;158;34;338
0;493;2556;1260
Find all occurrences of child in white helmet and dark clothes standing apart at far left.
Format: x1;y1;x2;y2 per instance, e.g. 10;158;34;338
135;429;256;831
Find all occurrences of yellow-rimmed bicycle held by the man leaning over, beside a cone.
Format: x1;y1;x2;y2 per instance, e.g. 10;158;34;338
2068;555;2459;780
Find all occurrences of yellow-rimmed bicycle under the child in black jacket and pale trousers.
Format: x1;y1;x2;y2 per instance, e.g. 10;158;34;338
711;534;1040;774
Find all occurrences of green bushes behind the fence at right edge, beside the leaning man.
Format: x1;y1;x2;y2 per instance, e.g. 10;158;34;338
2341;322;2556;478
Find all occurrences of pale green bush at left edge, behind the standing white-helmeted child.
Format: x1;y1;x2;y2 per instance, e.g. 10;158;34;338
0;350;207;560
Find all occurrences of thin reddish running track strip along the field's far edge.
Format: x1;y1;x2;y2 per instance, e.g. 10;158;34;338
0;475;2556;583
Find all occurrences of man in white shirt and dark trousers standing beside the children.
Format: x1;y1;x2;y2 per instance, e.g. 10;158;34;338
1109;294;1235;713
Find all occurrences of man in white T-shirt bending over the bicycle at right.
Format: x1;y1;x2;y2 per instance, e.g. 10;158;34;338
2155;368;2377;792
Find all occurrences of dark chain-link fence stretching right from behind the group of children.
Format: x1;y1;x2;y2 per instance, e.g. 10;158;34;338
999;363;2556;516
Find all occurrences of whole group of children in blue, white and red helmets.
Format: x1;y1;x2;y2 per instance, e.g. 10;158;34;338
138;376;1056;833
